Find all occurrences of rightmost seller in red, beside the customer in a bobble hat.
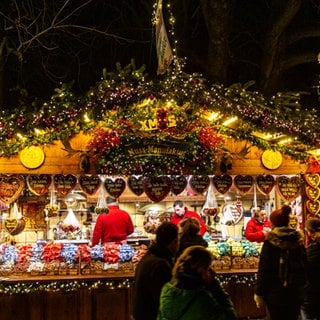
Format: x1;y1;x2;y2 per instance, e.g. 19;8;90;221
245;208;271;242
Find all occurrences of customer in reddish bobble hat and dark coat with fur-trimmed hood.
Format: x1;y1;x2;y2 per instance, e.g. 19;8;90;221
254;205;307;320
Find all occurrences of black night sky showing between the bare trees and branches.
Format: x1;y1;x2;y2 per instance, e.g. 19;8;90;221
0;0;320;106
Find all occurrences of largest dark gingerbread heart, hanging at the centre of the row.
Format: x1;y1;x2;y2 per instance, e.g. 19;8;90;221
143;176;171;202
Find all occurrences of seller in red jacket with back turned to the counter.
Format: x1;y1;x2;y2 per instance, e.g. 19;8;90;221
91;197;134;246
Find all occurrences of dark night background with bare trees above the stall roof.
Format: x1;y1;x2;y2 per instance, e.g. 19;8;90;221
0;0;320;108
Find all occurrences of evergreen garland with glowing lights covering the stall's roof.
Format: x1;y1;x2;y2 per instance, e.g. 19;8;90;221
0;59;319;173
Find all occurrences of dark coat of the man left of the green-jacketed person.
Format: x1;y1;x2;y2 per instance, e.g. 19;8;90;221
133;244;174;320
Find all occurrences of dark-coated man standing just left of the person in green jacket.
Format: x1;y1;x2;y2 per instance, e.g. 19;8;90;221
133;221;178;320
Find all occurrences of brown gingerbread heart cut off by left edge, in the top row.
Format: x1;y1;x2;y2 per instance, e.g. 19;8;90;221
0;174;25;203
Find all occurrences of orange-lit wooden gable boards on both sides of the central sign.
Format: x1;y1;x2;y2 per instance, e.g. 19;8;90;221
0;134;307;175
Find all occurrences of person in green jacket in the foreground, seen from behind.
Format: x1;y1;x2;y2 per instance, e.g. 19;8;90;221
157;246;237;320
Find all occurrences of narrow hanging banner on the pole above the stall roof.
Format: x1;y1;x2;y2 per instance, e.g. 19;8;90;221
156;0;173;74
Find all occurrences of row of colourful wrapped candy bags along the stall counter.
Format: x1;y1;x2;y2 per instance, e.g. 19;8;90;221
0;239;261;275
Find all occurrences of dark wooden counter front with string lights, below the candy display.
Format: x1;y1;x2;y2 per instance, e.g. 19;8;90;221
0;269;265;320
